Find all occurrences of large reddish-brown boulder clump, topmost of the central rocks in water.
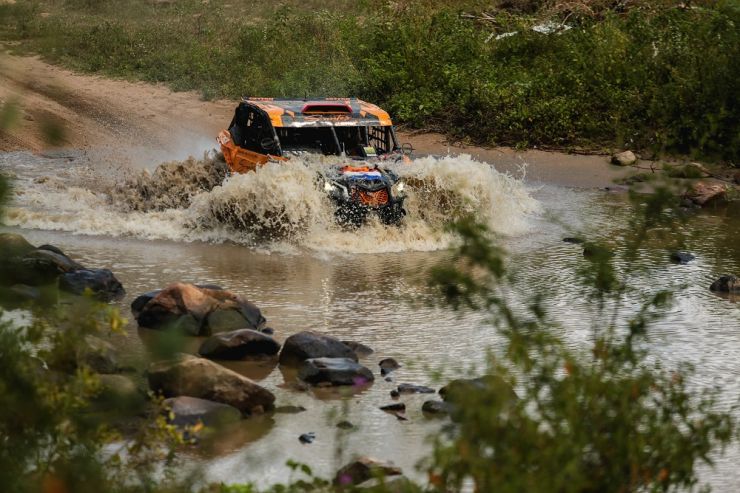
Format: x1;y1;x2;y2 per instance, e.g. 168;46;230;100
131;283;266;335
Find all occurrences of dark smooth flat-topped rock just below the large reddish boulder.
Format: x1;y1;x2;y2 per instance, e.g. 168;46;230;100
198;329;280;360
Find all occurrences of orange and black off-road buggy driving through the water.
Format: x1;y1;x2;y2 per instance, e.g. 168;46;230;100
218;98;412;226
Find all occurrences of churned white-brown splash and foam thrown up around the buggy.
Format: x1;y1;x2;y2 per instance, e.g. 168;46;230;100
3;151;540;253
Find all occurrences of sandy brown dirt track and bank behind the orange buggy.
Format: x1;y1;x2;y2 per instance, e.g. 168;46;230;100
0;54;626;187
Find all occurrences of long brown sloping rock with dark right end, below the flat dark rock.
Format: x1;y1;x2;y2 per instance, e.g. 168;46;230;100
147;355;275;413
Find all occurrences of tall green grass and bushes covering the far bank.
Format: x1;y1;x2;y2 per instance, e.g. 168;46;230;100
0;0;740;163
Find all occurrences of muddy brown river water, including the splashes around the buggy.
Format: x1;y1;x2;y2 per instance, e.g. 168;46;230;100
0;154;740;491
